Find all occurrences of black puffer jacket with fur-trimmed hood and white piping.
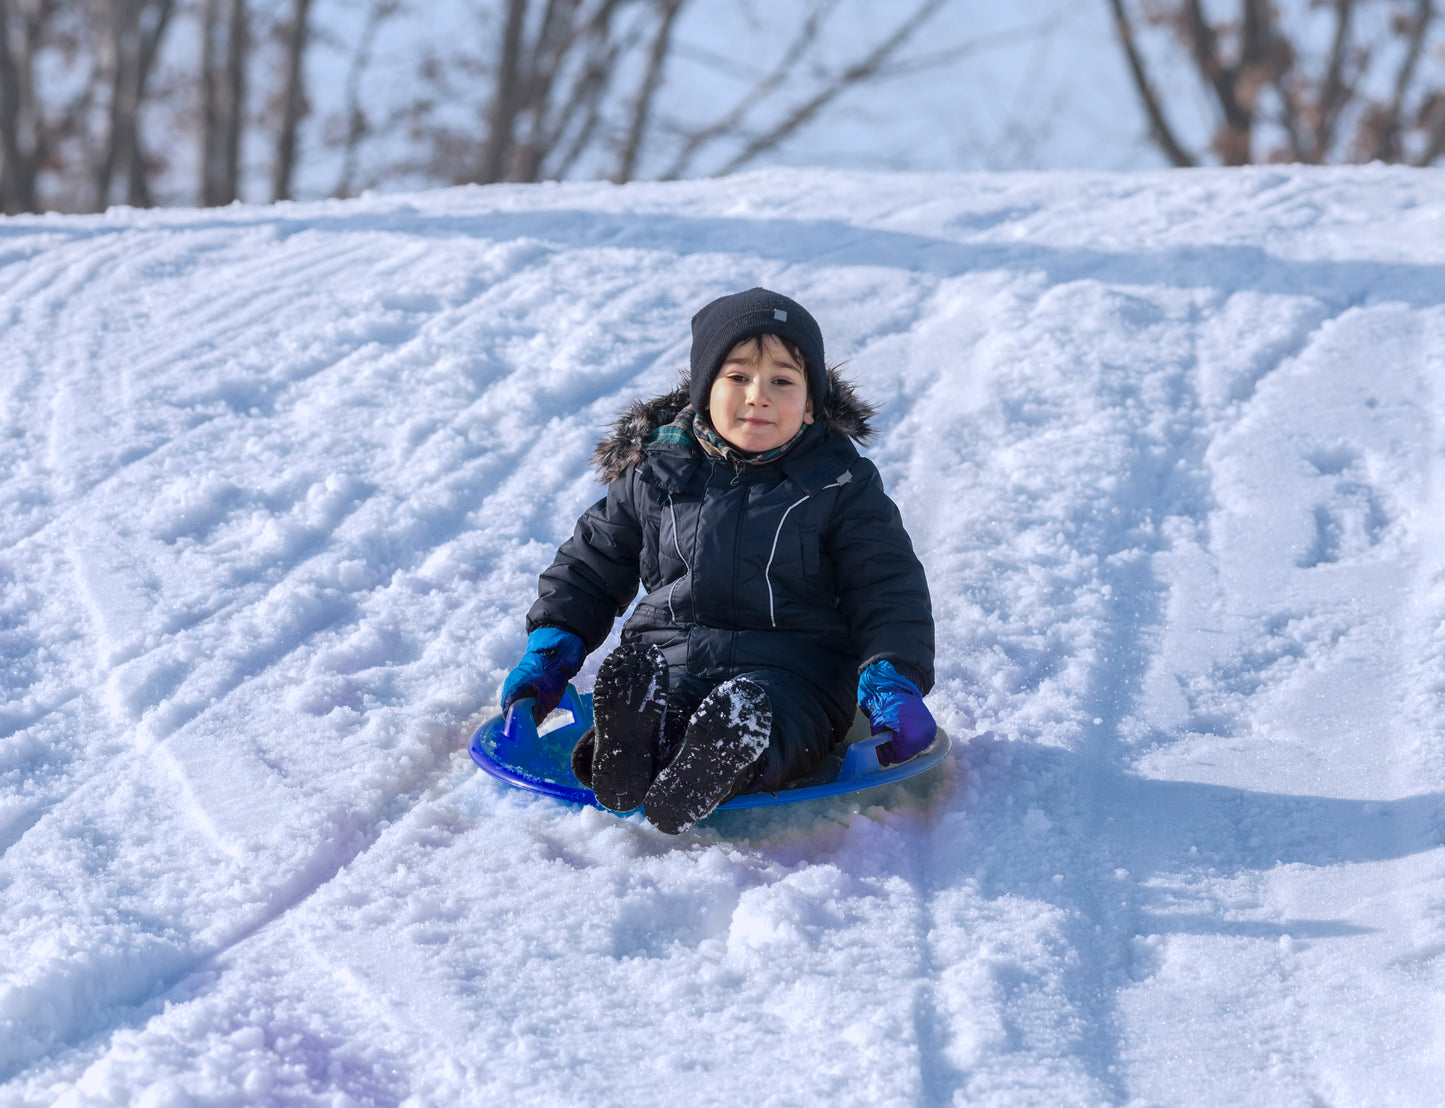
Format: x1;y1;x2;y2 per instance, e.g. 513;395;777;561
527;376;933;747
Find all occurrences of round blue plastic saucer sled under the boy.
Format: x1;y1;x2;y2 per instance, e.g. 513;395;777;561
468;685;952;812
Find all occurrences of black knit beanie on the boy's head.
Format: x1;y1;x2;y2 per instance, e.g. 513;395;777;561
688;289;828;415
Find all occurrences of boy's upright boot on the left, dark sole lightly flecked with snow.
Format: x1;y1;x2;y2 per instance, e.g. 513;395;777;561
592;644;668;812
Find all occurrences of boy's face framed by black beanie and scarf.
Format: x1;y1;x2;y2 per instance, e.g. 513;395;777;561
708;335;814;454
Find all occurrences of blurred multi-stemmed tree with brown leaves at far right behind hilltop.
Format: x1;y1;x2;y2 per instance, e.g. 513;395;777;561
1108;0;1445;166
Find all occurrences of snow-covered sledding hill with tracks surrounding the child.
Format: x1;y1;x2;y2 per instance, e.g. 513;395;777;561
0;168;1445;1108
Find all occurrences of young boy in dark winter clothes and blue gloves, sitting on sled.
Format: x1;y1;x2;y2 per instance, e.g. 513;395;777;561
501;289;936;835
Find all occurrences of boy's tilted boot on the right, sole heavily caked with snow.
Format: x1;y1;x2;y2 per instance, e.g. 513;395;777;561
643;678;773;835
